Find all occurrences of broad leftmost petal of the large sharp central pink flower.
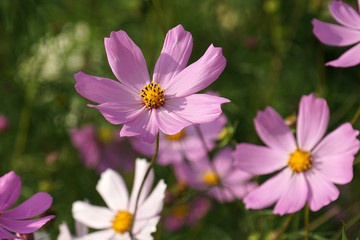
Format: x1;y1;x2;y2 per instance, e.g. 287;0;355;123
74;72;140;103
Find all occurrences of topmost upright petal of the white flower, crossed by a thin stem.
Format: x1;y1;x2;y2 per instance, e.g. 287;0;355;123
128;158;154;212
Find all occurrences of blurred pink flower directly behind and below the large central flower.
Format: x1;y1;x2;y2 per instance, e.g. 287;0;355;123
131;115;227;165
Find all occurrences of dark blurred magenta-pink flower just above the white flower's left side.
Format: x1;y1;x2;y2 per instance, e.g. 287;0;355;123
70;125;135;173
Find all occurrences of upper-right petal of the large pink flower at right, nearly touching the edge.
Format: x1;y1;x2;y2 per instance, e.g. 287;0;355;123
312;123;360;158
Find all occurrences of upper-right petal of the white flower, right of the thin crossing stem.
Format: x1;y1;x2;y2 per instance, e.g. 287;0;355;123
135;179;166;221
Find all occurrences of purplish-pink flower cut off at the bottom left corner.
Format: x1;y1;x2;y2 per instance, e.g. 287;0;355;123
0;171;55;239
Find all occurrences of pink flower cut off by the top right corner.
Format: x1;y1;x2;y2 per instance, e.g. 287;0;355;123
312;0;360;67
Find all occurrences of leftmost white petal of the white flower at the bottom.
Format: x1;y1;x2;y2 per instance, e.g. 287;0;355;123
72;201;116;229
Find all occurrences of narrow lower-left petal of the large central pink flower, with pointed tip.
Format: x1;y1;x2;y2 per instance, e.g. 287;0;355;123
88;102;147;125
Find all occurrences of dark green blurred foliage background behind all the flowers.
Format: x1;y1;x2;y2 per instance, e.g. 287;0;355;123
0;0;360;239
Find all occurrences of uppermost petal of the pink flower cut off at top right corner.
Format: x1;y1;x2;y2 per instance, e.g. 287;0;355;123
329;0;360;29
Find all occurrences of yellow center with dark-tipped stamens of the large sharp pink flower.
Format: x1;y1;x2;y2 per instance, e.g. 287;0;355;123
140;82;165;109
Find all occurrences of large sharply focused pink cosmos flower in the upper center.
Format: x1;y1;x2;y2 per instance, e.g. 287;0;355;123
74;25;229;143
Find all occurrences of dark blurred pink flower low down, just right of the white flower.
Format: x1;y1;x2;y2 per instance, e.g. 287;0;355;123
163;197;211;232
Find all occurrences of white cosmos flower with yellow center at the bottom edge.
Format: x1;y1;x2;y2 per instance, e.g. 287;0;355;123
72;159;166;240
